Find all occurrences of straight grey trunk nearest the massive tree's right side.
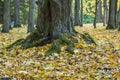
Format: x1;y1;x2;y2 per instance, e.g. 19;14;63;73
75;0;80;26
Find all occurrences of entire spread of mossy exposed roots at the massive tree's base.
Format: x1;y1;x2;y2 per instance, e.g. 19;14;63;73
7;30;97;56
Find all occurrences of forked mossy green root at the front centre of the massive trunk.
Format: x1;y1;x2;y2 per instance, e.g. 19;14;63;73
45;33;78;56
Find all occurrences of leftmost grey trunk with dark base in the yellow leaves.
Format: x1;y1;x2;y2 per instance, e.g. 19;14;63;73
2;0;10;33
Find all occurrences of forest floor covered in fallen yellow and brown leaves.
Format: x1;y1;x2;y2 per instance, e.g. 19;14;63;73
0;25;120;80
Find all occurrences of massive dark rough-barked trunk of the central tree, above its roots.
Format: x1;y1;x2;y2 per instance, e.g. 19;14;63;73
37;0;73;38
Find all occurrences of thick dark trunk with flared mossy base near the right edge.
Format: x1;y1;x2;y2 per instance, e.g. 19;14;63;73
106;0;117;29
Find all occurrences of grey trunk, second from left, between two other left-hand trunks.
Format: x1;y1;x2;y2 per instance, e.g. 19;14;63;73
14;0;21;27
